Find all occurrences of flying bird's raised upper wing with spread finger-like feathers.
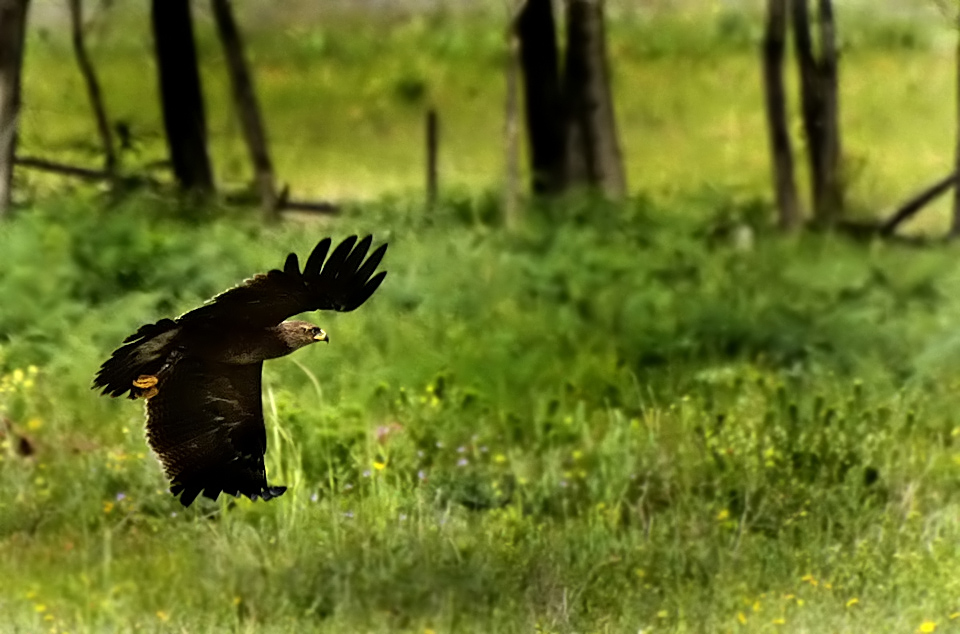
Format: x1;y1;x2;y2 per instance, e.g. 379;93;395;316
177;236;387;328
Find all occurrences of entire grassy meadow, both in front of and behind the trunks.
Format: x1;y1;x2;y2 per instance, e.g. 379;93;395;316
0;1;960;634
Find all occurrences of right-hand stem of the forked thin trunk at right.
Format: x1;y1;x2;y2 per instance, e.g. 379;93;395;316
817;0;845;222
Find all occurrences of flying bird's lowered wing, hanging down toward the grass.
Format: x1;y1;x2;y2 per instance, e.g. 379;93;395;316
147;353;285;506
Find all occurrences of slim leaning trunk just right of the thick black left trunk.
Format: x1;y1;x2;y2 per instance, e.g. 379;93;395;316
212;0;280;222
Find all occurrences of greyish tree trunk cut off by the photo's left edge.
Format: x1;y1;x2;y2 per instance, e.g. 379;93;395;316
0;0;29;220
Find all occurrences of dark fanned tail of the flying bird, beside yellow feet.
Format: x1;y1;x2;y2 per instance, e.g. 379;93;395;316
93;319;179;398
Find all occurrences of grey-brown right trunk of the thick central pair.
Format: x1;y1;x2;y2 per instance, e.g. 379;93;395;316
564;0;627;198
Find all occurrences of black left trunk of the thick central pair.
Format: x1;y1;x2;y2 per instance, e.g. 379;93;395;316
514;0;566;194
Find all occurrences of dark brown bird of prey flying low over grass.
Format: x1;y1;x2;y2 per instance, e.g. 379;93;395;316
93;236;387;506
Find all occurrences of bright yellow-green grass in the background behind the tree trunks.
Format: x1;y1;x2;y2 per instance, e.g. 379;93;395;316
16;3;955;231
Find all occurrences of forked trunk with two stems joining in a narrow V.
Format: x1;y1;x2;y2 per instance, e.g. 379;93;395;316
791;0;844;225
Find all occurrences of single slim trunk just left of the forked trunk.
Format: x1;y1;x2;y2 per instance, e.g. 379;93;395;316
763;0;803;231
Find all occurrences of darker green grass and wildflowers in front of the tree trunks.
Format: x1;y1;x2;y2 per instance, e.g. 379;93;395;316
0;191;960;632
